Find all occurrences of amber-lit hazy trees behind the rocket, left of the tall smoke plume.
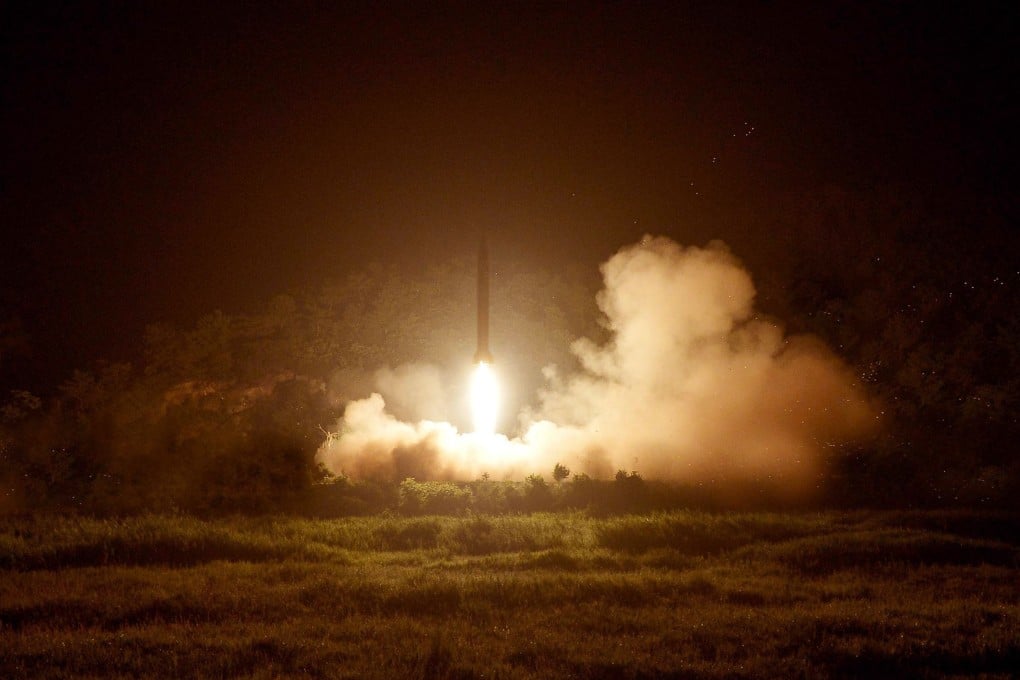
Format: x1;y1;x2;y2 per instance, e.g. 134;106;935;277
0;260;594;514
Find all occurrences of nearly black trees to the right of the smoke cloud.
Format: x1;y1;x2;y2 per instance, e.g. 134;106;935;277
764;190;1020;504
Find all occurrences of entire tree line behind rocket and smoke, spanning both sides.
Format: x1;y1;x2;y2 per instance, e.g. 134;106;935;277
0;190;1020;514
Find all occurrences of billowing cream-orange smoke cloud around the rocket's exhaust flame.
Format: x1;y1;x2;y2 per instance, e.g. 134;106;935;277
319;237;874;488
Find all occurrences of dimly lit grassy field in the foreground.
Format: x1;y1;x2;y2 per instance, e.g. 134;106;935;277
0;512;1020;678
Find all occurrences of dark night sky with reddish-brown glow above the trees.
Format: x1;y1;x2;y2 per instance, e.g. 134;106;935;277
0;2;1018;387
